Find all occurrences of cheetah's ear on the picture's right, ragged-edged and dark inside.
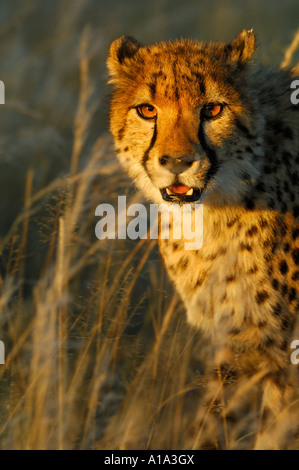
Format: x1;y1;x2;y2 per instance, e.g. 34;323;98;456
226;29;256;64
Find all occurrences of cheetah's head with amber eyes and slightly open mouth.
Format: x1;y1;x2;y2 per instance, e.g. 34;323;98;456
107;31;264;205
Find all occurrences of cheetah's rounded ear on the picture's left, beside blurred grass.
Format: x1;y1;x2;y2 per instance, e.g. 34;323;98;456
107;36;143;83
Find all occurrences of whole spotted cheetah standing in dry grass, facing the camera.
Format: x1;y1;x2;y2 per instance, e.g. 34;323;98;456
107;30;299;449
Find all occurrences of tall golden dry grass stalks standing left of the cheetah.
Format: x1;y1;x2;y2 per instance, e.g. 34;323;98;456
0;20;206;449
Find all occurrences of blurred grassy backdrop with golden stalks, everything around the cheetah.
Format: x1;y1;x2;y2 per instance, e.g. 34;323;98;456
0;0;299;449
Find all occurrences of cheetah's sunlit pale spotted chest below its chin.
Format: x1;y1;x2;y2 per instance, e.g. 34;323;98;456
160;207;275;332
